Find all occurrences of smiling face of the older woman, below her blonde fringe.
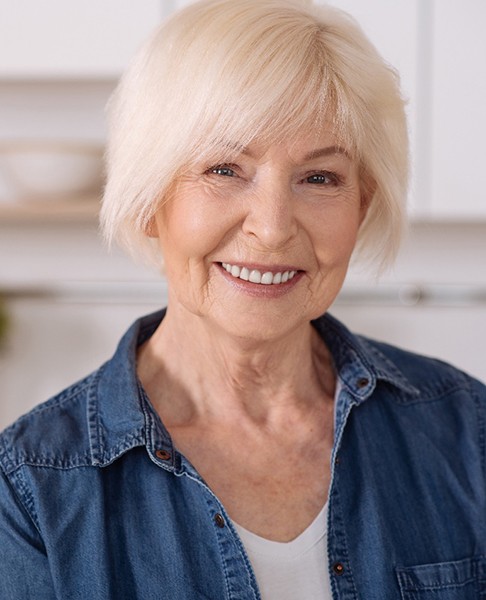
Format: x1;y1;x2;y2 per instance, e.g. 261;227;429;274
154;134;366;340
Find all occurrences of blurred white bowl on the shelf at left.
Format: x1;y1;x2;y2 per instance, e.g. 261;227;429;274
0;141;103;200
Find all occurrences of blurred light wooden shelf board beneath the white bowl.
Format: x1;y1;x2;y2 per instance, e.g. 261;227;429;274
0;196;100;226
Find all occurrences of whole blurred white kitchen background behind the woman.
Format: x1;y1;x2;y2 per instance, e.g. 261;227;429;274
0;0;486;428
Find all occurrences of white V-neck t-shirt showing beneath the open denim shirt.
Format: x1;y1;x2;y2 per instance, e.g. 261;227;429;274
234;504;332;600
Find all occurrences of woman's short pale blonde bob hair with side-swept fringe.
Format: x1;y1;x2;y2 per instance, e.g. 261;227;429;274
101;0;408;267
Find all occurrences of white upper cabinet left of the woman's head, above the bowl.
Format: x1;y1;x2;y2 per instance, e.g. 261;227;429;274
0;0;164;80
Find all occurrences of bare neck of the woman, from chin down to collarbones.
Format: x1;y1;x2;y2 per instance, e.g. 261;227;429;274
138;309;335;426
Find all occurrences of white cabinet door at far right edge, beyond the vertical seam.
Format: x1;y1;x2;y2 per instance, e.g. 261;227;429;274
431;0;486;220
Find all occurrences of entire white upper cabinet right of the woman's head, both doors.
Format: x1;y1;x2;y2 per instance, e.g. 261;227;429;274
333;0;486;221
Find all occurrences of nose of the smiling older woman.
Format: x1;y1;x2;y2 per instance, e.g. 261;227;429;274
243;185;298;250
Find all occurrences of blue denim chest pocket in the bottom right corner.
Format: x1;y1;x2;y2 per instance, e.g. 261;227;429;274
396;556;486;600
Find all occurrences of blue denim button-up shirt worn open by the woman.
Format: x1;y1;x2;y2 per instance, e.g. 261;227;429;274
0;312;486;600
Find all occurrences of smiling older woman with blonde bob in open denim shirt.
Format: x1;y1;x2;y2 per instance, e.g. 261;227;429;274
0;0;486;600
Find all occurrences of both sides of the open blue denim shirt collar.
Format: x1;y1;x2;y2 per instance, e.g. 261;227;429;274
87;310;418;471
